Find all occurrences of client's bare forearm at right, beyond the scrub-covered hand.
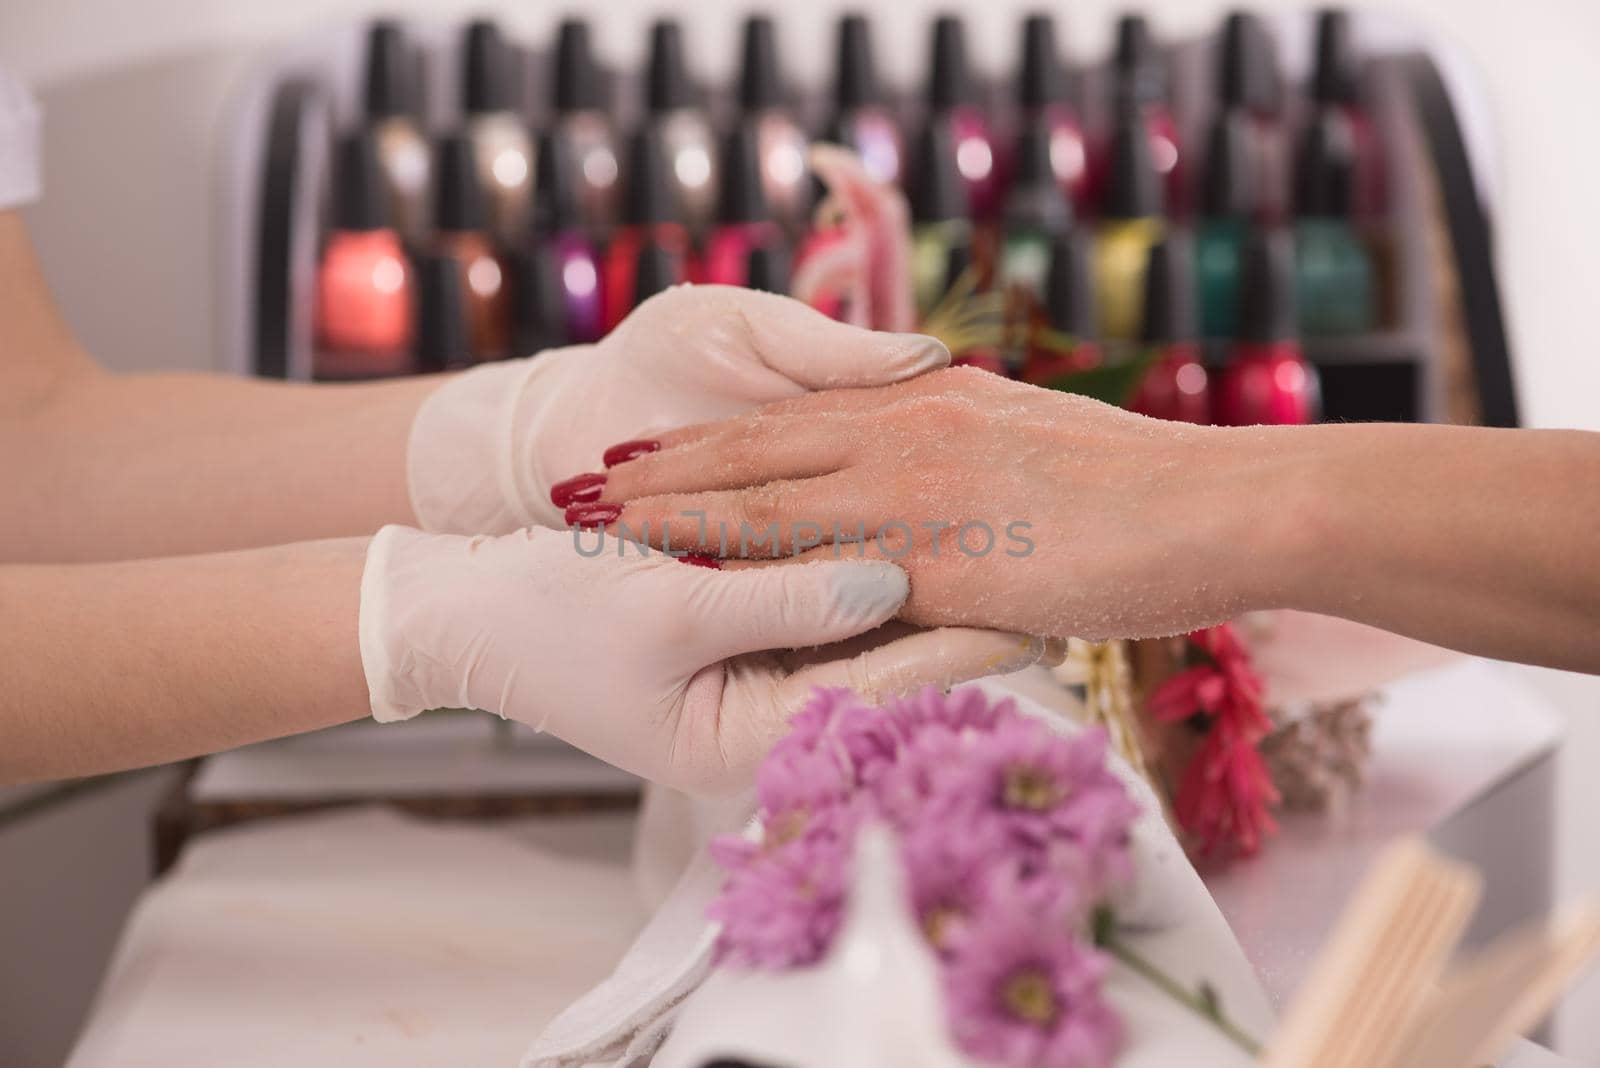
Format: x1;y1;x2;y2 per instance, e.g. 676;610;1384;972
1238;425;1600;671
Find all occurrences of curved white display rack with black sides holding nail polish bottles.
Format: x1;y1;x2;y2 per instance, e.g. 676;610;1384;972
218;10;1517;425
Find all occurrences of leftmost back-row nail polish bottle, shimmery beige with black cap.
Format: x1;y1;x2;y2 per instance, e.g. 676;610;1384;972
366;19;432;243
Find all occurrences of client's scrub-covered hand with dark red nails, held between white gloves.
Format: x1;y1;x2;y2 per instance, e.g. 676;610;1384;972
574;369;1275;638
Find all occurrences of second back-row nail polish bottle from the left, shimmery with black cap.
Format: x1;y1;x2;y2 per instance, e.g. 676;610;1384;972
461;19;533;241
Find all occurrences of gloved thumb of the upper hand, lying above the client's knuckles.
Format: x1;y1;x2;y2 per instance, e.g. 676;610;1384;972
694;286;950;390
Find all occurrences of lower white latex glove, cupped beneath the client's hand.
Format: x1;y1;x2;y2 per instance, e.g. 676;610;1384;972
360;526;1043;795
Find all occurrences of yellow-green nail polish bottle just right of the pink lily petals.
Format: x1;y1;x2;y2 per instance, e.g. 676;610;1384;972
906;122;973;317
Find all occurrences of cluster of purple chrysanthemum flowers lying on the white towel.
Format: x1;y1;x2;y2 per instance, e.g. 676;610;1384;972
710;689;1138;1068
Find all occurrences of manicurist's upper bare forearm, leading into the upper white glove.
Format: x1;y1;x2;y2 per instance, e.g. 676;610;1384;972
0;213;438;561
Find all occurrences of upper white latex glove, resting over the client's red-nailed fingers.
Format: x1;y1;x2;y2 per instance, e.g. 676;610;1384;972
406;286;950;534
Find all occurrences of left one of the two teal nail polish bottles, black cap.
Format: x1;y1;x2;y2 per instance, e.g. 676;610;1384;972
1195;110;1256;337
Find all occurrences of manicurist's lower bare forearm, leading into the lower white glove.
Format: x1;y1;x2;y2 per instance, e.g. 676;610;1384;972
0;539;368;782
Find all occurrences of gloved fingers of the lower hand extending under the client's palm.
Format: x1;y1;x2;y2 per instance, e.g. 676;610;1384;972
782;627;1046;707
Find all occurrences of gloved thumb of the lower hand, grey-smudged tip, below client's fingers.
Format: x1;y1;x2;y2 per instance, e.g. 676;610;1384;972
682;560;910;664
